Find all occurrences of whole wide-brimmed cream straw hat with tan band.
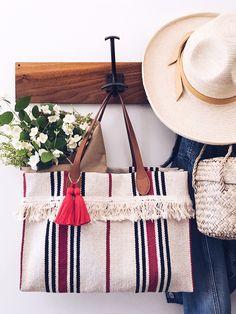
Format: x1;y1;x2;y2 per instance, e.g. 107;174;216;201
142;13;236;145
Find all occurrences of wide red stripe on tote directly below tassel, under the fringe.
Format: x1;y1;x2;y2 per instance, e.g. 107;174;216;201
58;225;68;292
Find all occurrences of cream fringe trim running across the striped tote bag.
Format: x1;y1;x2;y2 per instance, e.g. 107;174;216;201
17;196;195;222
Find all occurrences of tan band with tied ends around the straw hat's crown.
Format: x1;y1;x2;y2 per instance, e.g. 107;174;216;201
169;32;236;105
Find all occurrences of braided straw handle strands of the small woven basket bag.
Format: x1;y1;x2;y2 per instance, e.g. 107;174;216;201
192;144;233;193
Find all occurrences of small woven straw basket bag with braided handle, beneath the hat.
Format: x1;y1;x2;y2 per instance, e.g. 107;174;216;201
193;145;236;240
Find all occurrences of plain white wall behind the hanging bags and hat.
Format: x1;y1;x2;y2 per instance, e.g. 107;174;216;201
0;0;236;314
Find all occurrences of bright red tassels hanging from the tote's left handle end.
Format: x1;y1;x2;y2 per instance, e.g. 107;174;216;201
54;184;90;226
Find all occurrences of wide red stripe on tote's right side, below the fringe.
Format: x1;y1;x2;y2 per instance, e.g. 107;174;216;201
146;220;158;292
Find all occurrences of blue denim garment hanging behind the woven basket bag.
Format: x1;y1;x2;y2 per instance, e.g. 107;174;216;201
166;137;236;314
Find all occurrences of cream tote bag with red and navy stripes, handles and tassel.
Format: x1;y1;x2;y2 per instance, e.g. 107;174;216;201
19;95;194;293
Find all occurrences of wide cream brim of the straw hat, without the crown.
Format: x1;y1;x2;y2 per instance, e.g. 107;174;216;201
142;13;236;145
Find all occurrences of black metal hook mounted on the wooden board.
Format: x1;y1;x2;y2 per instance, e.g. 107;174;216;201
102;36;128;96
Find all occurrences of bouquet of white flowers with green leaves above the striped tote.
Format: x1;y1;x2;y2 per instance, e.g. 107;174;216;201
0;96;91;170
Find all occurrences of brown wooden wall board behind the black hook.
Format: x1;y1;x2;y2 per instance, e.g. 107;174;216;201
15;62;148;104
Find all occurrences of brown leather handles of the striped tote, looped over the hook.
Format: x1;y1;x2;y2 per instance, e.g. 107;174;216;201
70;93;150;195
